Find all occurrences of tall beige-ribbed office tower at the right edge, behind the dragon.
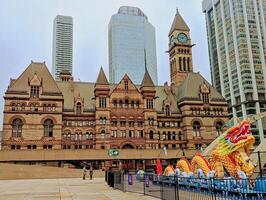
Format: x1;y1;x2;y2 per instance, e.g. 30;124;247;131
202;0;266;141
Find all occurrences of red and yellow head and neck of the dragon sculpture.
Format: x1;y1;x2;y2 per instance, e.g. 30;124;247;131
218;120;255;176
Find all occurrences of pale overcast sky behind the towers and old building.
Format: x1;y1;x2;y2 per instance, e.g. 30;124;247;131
0;0;210;128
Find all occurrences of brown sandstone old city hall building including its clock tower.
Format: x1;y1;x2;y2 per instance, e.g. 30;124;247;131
2;11;227;156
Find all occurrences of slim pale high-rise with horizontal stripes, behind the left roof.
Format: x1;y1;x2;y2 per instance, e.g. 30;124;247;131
52;15;73;80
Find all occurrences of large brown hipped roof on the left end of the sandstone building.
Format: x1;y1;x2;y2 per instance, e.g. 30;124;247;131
7;61;62;95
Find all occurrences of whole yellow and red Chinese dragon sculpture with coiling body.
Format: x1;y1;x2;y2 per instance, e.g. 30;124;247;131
177;120;255;178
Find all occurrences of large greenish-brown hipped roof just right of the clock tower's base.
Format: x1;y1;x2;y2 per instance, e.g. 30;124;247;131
177;72;225;101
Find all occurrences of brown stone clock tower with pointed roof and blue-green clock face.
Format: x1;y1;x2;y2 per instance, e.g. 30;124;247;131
168;9;193;85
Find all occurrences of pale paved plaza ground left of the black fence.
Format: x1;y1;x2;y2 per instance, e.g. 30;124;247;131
0;178;155;200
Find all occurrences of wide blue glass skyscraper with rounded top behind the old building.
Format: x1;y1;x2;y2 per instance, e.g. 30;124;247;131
108;6;158;85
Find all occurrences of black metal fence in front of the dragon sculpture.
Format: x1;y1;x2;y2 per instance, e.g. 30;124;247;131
107;172;266;200
